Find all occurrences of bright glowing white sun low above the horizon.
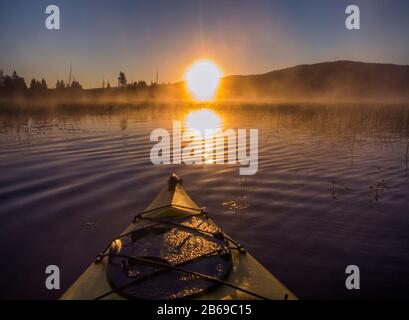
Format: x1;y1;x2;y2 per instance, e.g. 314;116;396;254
185;60;221;101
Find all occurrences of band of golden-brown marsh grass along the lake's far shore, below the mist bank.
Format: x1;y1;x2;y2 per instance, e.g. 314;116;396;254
0;102;409;141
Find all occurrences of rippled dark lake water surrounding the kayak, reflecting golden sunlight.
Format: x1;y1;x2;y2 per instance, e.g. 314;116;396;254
0;105;409;299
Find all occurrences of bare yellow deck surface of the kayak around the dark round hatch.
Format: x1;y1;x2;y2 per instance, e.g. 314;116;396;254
61;175;297;300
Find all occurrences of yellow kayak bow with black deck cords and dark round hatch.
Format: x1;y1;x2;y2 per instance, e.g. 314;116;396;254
61;174;297;300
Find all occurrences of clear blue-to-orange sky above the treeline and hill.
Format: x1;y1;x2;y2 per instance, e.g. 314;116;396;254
0;0;409;88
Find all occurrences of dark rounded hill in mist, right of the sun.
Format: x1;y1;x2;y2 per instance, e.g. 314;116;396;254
219;61;409;102
